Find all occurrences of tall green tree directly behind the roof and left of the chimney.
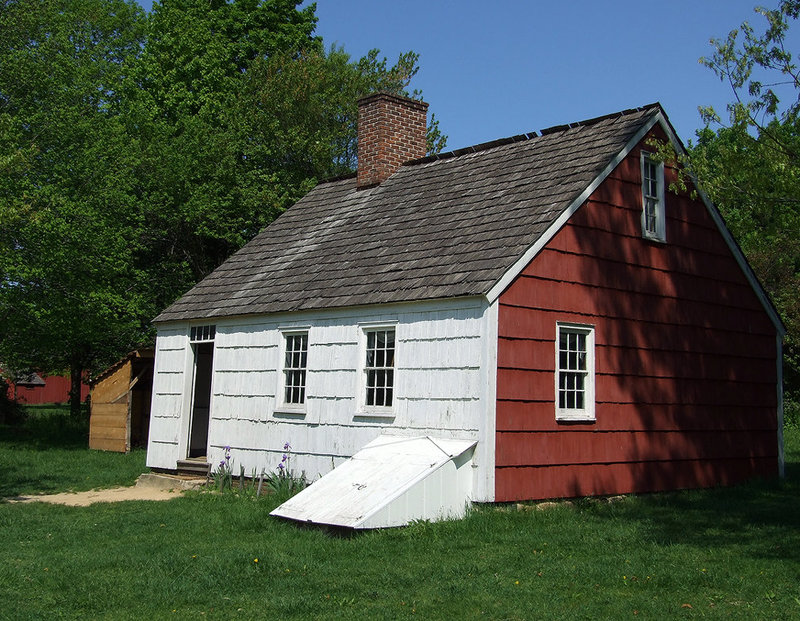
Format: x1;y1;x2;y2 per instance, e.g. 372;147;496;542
138;0;444;286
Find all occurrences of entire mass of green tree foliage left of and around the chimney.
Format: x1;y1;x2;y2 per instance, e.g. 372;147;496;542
0;0;446;416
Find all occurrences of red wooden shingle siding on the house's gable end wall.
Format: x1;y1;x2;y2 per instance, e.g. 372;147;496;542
495;128;778;501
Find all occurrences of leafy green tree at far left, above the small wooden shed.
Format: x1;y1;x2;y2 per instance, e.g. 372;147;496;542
0;0;151;412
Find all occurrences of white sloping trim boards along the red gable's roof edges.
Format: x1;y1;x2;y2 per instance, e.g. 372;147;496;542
486;110;786;337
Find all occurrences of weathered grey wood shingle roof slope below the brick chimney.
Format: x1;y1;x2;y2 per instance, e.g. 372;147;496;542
156;104;661;322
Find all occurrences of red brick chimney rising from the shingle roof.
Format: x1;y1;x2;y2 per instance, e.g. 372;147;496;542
358;93;428;188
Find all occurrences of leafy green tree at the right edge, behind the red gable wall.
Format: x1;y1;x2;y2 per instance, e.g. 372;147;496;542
689;0;800;420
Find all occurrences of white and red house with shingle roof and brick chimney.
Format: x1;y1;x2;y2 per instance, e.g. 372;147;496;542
148;94;784;524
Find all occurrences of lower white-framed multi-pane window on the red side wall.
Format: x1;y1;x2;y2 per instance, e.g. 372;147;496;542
556;325;594;420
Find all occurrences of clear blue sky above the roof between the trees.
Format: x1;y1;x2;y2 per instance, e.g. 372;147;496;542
134;0;800;150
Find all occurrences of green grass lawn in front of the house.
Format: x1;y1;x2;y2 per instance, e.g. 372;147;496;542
0;410;800;620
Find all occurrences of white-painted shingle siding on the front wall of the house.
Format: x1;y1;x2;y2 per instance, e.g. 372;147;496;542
148;298;495;495
